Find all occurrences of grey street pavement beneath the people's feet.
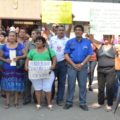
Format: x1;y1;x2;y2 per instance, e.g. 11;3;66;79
0;69;120;120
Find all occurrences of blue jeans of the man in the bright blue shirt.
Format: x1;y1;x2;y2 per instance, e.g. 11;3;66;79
66;64;87;105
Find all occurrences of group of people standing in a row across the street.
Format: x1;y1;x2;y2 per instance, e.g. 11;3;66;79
0;25;120;111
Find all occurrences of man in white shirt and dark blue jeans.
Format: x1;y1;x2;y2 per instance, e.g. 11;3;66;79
50;25;68;105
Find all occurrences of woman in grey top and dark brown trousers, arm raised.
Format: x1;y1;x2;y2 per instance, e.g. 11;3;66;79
91;35;115;111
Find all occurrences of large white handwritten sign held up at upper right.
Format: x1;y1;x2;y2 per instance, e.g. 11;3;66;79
90;4;120;35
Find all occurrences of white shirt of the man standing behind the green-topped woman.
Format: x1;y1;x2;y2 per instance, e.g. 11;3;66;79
49;36;68;62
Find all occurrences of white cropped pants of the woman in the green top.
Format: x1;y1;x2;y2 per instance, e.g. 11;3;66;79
31;72;55;92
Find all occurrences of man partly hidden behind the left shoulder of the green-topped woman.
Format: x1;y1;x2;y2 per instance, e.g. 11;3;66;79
23;29;38;105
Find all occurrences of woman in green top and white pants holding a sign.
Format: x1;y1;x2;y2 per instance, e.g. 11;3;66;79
25;36;56;109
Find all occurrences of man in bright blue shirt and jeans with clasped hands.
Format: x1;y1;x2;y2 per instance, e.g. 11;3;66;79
64;25;93;111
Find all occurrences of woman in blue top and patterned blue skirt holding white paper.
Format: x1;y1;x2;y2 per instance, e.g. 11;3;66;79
0;31;26;108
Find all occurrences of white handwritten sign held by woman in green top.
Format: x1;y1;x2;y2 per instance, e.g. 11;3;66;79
28;61;51;80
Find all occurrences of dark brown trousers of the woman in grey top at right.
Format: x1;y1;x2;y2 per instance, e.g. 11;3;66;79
98;70;115;106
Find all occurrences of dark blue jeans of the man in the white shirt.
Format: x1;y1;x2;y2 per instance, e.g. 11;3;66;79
55;60;67;102
